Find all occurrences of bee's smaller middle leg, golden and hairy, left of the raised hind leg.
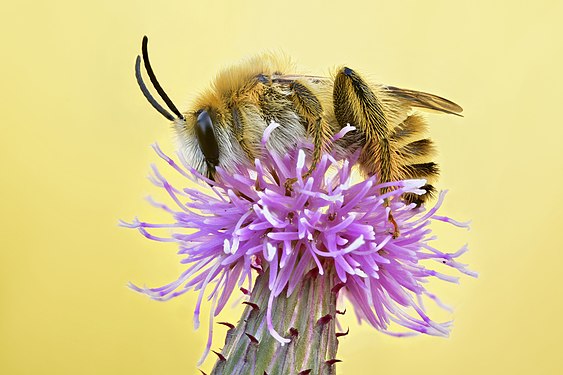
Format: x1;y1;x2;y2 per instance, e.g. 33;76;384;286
285;81;332;191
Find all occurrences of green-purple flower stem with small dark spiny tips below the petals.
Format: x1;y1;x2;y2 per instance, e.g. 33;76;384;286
211;267;340;375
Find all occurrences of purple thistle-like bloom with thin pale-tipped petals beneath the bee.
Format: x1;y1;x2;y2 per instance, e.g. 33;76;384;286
122;124;476;364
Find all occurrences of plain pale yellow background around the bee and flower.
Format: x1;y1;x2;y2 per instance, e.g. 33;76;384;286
0;0;563;375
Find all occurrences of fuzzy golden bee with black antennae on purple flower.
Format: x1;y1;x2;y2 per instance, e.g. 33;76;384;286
135;36;462;214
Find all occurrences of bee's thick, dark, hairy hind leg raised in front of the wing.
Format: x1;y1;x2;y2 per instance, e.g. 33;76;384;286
333;67;400;238
